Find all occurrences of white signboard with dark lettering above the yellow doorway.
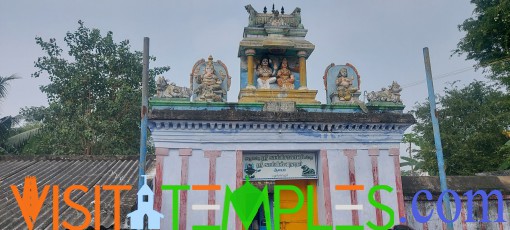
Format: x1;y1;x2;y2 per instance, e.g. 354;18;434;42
243;152;317;181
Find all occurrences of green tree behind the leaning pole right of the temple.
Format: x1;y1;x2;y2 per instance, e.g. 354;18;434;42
413;81;510;175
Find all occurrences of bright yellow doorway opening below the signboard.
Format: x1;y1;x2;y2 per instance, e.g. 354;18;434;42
248;179;318;230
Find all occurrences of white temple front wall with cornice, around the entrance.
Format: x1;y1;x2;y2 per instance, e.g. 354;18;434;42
152;121;403;229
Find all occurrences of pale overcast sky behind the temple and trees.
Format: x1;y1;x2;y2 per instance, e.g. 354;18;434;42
0;0;485;117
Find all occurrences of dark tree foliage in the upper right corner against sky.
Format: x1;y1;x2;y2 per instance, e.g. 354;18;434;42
454;0;510;87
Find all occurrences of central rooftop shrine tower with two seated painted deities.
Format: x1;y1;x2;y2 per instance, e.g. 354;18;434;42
238;5;320;104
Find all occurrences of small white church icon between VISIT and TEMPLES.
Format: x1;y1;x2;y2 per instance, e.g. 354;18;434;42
127;175;164;229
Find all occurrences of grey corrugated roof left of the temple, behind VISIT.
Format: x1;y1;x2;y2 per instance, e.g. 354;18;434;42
0;156;154;229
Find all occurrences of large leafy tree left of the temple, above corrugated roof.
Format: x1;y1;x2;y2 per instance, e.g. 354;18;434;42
28;21;170;154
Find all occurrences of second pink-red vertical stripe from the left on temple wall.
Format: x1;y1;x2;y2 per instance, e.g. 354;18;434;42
179;149;191;229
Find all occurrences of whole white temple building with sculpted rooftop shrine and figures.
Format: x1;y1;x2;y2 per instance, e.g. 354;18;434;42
149;5;415;230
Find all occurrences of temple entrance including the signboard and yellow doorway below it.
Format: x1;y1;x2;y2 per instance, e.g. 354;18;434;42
243;151;318;230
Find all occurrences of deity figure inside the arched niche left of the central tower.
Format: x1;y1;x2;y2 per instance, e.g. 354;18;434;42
196;56;225;102
